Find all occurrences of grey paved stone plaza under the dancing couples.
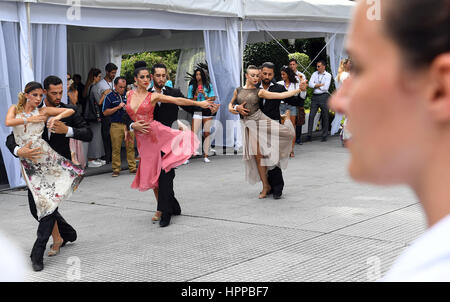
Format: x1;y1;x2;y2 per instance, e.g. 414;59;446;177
0;137;425;282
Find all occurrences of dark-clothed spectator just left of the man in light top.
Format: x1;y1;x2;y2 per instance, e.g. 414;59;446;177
83;68;106;168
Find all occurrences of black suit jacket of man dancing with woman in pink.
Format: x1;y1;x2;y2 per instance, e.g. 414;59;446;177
122;87;202;128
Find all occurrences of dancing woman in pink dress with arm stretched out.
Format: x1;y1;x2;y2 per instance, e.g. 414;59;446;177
126;67;211;192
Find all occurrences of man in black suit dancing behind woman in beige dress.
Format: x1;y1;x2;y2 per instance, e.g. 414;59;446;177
236;62;295;199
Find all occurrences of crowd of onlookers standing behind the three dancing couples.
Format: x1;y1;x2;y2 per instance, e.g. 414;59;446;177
67;59;350;176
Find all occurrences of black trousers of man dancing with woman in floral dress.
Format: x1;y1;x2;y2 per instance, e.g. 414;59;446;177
28;190;77;263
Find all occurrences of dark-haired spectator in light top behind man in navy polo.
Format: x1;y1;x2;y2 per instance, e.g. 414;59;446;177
94;63;118;163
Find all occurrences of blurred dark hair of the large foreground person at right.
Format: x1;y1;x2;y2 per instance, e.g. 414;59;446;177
383;0;450;67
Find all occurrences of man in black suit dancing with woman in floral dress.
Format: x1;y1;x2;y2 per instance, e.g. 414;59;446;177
6;76;92;271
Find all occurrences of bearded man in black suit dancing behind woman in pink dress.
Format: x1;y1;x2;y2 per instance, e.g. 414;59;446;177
123;62;218;227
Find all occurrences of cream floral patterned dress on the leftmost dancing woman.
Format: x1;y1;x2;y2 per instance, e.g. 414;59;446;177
13;108;84;220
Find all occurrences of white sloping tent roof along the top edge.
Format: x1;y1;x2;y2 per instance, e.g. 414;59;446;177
7;0;354;21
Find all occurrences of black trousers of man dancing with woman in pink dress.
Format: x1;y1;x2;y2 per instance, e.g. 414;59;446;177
157;169;181;215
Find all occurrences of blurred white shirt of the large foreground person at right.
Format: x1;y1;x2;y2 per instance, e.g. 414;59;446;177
380;215;450;282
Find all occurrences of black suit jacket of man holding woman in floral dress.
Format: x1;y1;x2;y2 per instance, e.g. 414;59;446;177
6;103;92;159
